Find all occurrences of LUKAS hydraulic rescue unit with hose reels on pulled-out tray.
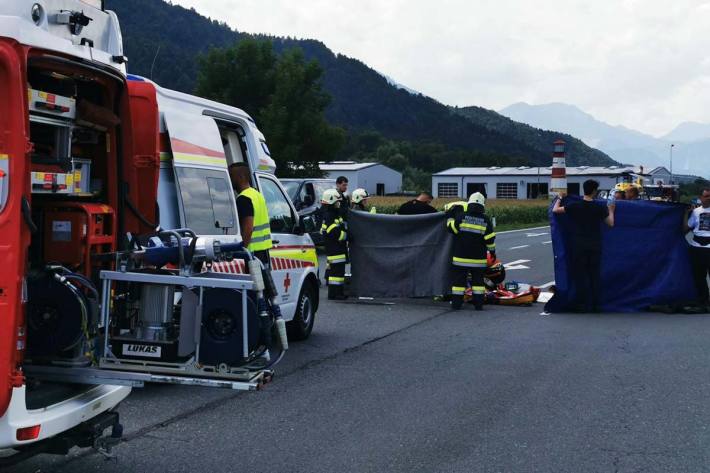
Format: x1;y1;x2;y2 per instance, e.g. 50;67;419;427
26;229;288;390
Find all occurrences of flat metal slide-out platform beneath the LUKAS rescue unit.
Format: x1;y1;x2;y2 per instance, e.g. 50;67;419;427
25;365;273;391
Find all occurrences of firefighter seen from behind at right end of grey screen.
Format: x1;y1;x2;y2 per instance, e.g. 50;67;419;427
446;192;496;310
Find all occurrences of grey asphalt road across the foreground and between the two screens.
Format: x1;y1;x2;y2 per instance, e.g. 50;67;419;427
16;229;710;473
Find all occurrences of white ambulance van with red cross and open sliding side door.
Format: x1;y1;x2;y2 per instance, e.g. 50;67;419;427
145;75;319;340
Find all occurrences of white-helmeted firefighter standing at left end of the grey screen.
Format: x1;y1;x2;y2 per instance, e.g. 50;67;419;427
320;189;348;300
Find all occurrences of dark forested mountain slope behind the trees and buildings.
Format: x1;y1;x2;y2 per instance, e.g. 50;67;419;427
106;0;613;172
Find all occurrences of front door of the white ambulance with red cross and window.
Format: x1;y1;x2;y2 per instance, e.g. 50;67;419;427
256;173;317;320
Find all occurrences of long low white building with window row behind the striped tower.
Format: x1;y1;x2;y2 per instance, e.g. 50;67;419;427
432;166;652;199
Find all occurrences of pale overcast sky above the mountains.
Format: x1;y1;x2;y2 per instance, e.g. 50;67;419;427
172;0;710;135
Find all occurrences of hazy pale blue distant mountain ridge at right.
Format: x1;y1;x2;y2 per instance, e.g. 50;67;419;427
500;102;710;177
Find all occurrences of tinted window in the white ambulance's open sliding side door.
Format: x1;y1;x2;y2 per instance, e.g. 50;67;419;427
176;167;237;235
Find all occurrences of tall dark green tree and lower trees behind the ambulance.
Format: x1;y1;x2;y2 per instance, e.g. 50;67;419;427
195;38;526;190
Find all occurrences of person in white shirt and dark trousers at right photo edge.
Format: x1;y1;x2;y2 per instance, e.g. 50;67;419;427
685;188;710;307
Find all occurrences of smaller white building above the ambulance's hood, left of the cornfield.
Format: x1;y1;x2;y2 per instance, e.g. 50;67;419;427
319;161;402;195
